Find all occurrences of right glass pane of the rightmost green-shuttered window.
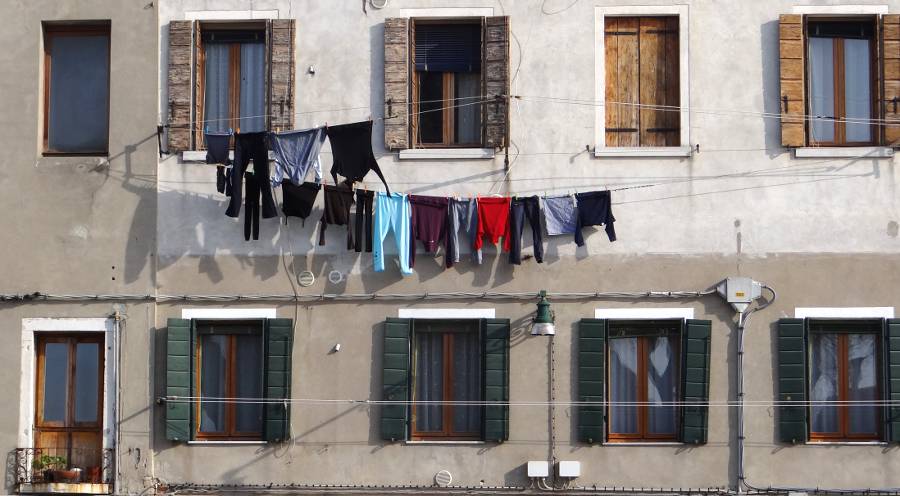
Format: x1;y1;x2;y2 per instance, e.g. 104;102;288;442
847;334;881;434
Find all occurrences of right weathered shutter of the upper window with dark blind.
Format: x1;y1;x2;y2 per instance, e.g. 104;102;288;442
481;16;509;148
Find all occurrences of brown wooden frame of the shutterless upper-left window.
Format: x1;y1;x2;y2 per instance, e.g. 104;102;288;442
41;22;112;157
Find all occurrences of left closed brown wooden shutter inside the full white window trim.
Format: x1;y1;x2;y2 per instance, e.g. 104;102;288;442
604;17;640;147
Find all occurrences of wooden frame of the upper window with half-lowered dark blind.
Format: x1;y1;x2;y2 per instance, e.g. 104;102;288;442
409;18;485;148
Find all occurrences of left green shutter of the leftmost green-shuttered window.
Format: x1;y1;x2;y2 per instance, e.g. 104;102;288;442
166;319;193;441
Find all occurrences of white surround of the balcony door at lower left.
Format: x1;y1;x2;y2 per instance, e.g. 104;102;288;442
18;318;118;449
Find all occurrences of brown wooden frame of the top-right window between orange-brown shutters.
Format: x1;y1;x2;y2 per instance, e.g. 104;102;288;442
803;16;880;148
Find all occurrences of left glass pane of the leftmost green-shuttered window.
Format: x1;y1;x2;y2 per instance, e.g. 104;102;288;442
200;334;228;432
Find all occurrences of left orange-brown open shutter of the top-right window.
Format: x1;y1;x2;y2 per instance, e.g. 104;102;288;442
778;14;806;147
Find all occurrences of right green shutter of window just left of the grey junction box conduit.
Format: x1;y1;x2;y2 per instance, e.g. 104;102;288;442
681;319;712;444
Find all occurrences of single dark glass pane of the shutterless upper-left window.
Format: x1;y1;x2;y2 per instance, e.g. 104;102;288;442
47;35;109;152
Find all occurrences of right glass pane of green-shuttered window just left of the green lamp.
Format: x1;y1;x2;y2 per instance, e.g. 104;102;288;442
453;332;481;432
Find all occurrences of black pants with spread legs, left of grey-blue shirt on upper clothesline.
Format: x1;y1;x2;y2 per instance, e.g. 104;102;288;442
225;132;278;219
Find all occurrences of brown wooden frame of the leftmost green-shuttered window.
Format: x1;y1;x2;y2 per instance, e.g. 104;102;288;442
194;321;265;441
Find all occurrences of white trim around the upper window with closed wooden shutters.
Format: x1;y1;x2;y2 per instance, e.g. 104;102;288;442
594;5;691;157
